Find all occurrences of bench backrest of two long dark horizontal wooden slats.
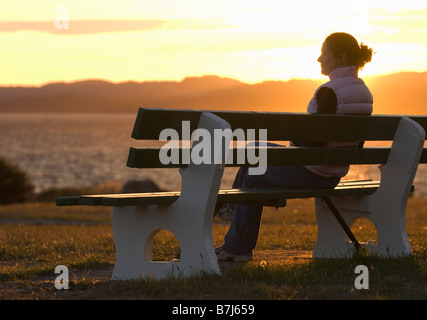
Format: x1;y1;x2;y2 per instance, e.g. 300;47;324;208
127;108;427;168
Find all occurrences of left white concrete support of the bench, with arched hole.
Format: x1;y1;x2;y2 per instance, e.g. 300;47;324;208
112;113;231;279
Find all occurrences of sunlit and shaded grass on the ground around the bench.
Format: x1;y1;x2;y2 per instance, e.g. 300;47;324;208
0;198;427;300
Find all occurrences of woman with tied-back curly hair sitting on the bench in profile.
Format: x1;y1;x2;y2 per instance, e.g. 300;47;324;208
215;33;373;262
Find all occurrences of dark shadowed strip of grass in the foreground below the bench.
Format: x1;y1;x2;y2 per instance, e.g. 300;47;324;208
51;250;427;300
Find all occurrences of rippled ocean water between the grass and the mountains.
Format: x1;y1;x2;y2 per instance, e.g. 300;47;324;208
0;113;427;197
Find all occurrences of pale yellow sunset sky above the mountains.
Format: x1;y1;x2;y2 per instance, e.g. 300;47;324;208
0;0;427;86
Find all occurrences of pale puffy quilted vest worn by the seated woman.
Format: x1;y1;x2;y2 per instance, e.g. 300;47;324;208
306;66;373;177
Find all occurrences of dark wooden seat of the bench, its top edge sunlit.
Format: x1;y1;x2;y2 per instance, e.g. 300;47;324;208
57;180;379;207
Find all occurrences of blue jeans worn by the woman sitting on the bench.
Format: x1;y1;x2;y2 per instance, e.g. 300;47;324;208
222;162;340;254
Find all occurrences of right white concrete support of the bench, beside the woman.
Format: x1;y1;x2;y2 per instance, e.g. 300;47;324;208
313;117;425;258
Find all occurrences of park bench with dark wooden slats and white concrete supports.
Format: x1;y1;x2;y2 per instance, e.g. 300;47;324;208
57;108;427;279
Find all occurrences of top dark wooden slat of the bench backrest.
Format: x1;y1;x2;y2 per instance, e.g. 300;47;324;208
132;108;427;141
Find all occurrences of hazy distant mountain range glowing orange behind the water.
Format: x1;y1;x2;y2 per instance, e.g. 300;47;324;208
0;72;427;114
